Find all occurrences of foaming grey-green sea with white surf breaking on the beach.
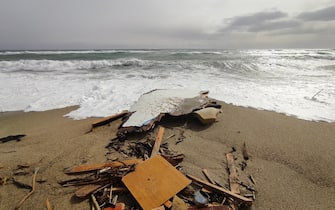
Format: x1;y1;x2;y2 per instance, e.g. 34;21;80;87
0;49;335;122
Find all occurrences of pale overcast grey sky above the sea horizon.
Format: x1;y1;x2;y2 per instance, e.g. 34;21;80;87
0;0;335;50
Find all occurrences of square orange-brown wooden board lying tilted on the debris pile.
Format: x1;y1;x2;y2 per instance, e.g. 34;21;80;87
122;155;191;210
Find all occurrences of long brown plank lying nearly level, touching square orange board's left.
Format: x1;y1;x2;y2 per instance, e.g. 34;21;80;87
64;159;143;174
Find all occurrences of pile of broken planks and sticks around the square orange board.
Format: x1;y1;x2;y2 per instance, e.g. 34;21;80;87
59;124;255;210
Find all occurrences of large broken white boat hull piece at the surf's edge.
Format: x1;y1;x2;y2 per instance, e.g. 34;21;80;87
117;89;221;138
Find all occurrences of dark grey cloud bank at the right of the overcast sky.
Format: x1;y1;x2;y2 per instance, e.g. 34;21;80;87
218;6;335;35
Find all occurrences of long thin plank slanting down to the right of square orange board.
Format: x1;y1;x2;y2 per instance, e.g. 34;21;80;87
187;175;253;205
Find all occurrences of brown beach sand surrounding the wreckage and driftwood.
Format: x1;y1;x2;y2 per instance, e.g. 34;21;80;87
0;103;335;210
